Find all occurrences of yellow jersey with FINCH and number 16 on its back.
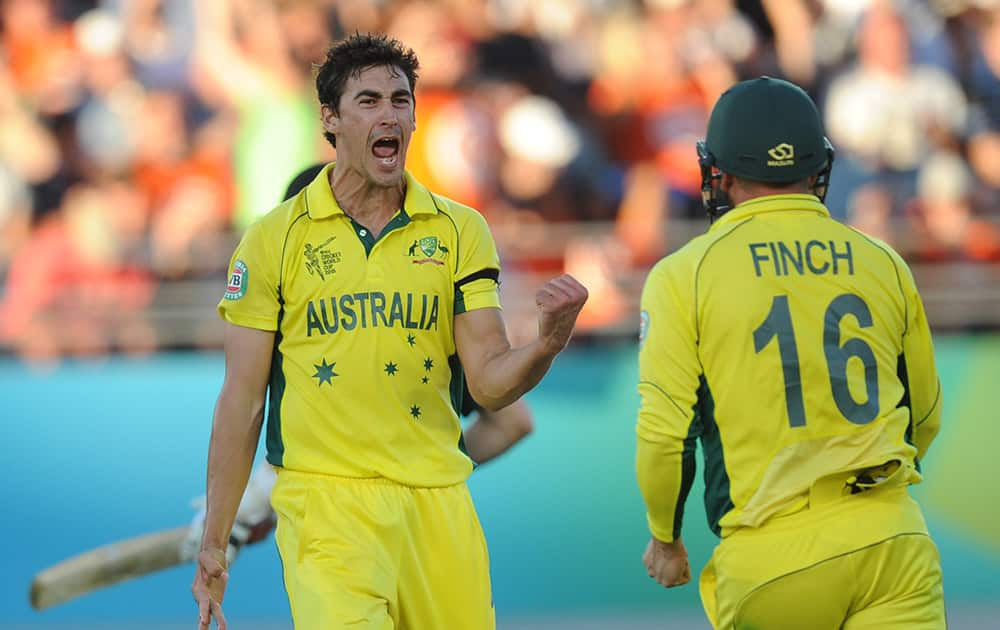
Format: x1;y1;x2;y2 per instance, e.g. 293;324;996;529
637;194;941;541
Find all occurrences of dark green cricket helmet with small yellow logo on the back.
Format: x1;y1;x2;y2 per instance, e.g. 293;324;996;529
698;76;833;218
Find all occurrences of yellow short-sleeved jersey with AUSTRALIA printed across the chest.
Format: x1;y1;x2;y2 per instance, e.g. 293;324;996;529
219;164;500;487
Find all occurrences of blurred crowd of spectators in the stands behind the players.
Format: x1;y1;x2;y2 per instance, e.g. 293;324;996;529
0;0;1000;358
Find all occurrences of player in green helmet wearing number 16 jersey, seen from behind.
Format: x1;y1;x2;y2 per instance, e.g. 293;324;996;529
636;77;945;630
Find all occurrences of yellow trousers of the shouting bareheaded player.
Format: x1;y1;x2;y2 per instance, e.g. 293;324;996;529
271;470;496;630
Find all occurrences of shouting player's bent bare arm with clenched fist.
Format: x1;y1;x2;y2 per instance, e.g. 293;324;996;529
455;275;587;411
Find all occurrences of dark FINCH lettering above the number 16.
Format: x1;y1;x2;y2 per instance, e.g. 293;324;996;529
748;240;854;278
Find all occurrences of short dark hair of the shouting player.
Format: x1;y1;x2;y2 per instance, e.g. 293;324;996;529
316;33;420;147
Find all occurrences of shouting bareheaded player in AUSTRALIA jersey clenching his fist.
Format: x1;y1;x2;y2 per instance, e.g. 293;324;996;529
192;33;587;630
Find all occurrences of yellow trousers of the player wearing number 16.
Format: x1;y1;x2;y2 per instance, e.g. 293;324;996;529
700;487;945;630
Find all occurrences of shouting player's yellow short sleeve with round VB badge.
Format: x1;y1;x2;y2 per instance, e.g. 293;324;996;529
218;222;280;331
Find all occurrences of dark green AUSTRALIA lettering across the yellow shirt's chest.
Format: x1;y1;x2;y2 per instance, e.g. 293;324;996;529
306;291;438;337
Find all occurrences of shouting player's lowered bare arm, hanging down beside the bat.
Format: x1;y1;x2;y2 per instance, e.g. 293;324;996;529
191;322;274;630
